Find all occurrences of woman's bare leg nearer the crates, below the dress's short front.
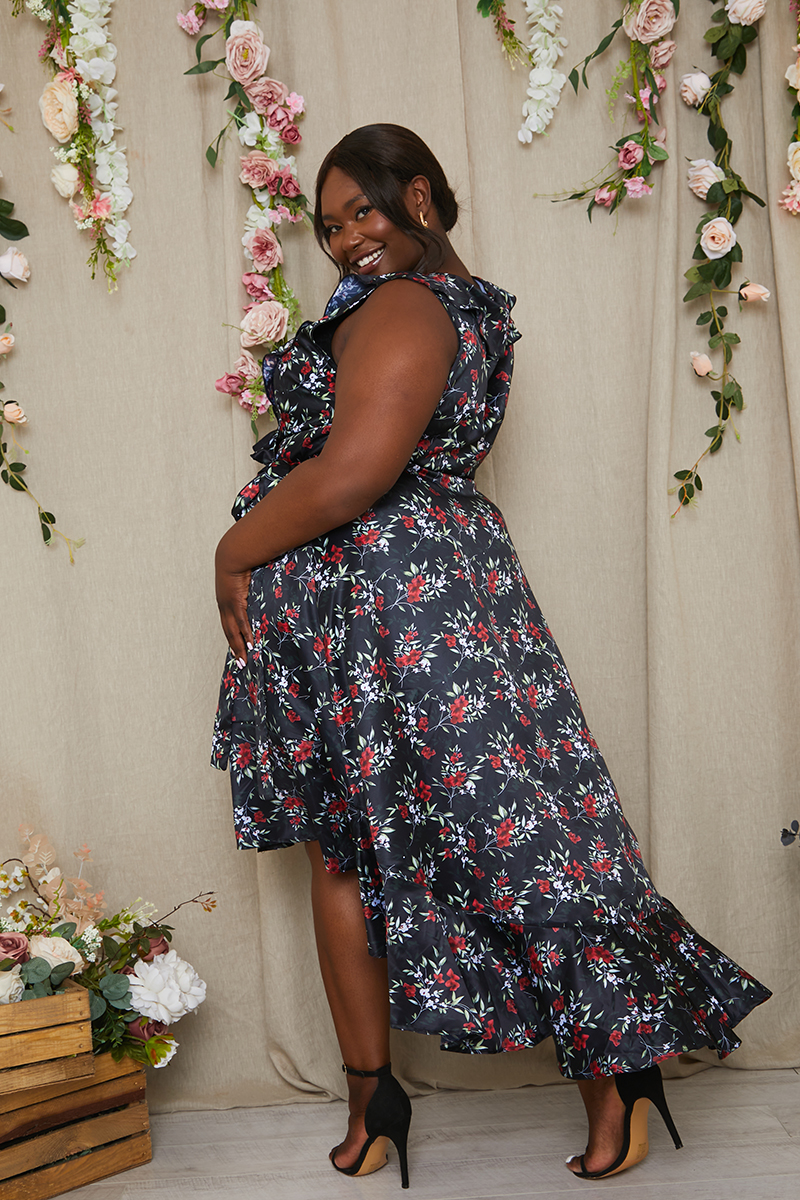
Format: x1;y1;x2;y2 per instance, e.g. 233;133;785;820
306;841;389;1166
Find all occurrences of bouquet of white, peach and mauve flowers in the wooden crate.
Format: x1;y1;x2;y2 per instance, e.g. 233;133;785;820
0;824;216;1067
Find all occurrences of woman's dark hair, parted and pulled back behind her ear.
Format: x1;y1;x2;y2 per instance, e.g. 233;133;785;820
314;124;458;275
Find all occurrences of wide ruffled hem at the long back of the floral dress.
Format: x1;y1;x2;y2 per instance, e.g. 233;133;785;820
389;899;771;1079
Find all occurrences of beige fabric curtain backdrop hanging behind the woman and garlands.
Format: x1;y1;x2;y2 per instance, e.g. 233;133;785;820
0;0;800;1110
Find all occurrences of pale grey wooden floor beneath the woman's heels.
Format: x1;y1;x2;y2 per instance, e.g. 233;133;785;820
64;1069;800;1200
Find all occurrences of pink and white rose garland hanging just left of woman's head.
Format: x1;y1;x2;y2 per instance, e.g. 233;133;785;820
178;0;309;438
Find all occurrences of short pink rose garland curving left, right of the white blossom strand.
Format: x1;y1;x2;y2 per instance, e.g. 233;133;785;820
555;0;680;221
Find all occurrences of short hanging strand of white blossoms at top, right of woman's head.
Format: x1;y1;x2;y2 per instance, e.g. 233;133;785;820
477;0;567;144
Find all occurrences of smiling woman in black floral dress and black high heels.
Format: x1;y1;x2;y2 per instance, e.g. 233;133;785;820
213;125;769;1187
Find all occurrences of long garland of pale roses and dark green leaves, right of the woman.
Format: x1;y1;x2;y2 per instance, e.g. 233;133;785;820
669;0;770;517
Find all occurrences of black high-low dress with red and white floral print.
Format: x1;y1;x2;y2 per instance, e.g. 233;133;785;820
212;275;770;1078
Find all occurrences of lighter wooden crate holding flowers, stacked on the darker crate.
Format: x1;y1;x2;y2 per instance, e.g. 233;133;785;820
0;979;95;1097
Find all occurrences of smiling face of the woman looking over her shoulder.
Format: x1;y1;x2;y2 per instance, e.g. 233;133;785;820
320;167;422;275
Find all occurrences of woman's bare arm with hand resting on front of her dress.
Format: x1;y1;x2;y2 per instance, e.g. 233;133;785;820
216;280;458;659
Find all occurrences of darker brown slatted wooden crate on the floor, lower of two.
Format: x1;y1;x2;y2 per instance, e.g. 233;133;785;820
0;1054;152;1200
